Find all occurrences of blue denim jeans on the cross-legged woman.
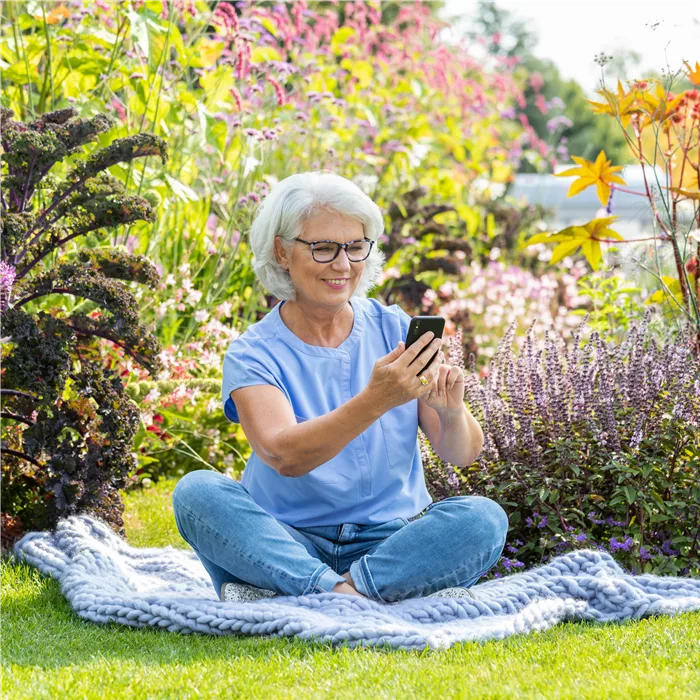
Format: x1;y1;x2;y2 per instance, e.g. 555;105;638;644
172;469;508;603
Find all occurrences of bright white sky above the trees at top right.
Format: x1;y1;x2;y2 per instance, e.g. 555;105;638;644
440;0;700;97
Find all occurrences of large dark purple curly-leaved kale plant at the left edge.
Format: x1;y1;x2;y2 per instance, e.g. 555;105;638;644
0;107;167;548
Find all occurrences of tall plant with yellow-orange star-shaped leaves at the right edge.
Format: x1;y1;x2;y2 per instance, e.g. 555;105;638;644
525;63;700;355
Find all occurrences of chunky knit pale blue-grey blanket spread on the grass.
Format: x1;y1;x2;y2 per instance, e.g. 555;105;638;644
14;515;700;649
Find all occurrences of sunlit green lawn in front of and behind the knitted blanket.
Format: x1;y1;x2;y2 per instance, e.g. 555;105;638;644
0;481;700;700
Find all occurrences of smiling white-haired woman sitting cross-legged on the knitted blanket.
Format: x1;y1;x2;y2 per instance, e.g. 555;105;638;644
173;171;508;603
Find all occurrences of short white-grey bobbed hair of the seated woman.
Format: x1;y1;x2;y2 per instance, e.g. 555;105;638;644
248;170;386;301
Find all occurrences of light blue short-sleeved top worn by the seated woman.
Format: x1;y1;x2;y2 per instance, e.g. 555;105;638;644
222;297;432;527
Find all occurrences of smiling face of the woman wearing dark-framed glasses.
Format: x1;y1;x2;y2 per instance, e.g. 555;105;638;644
274;211;365;307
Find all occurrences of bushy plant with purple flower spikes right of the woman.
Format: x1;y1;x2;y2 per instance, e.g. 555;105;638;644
427;309;700;576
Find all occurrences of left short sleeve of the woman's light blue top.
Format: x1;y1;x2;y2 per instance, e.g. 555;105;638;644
221;338;287;423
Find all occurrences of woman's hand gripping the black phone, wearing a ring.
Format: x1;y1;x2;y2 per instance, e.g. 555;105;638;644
367;331;442;411
